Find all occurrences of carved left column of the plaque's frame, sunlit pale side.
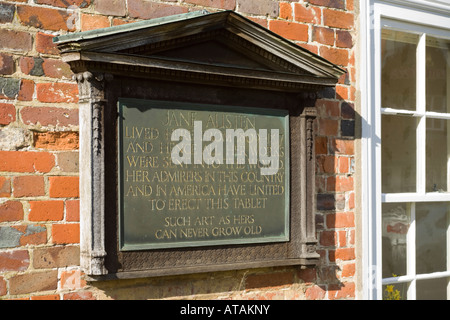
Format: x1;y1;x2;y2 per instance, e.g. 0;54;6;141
74;72;107;275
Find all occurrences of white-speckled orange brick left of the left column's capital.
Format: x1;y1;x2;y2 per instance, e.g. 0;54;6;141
36;82;78;103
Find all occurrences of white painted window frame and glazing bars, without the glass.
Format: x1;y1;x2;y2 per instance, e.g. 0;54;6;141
359;0;450;299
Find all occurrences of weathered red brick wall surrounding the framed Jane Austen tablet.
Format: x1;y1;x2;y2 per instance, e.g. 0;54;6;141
0;0;356;300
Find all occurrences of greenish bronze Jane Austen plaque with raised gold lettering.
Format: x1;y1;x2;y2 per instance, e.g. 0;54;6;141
118;99;289;251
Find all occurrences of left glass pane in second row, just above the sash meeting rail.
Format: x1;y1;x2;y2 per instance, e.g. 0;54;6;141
381;115;417;193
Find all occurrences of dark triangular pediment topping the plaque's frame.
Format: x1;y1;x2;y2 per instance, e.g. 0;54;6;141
55;11;344;86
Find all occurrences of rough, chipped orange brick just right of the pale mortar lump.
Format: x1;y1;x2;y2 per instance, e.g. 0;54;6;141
33;131;79;150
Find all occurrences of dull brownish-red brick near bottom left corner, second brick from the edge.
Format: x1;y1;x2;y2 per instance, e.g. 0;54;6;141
9;270;58;295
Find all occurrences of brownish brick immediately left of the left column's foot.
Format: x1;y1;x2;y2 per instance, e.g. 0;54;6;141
33;246;80;269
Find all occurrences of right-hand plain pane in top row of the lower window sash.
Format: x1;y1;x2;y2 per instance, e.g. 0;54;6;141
416;202;450;274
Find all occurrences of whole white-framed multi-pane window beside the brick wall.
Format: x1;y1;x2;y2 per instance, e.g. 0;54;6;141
362;1;450;300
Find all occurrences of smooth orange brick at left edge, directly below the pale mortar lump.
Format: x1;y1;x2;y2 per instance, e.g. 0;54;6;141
0;151;55;173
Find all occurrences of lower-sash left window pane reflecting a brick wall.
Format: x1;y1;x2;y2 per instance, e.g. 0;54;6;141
381;203;410;278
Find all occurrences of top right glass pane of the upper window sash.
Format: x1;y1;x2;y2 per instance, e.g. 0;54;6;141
426;36;450;112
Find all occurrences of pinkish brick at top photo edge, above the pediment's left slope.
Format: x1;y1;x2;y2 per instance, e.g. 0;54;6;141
128;0;188;19
